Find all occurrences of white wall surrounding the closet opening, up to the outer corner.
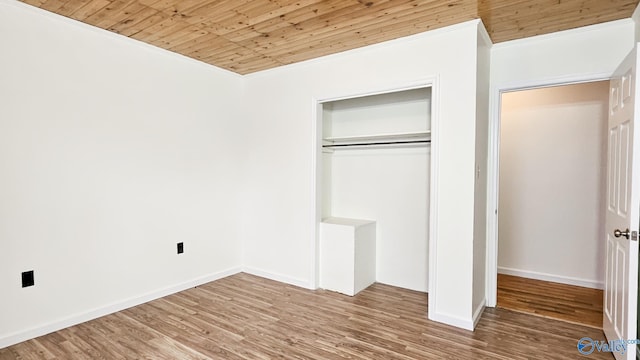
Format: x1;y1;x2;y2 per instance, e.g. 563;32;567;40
241;21;477;327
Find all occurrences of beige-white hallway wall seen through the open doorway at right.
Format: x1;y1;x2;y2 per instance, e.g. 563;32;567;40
498;81;609;288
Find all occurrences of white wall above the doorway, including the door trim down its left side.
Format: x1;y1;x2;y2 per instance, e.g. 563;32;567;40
487;19;635;306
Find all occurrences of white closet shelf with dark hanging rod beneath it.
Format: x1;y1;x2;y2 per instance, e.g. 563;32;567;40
322;131;431;149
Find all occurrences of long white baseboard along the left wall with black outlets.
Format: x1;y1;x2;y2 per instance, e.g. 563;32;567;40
0;267;242;349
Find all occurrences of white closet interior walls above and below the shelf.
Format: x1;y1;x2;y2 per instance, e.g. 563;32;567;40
322;88;431;292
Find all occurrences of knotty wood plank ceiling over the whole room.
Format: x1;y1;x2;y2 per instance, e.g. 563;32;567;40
17;0;640;74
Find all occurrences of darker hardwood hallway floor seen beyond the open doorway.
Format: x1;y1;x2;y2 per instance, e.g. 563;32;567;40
498;274;603;329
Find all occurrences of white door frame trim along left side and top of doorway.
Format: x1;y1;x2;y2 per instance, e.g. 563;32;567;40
485;73;612;307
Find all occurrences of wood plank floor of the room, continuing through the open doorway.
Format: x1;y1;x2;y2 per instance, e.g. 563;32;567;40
0;274;612;360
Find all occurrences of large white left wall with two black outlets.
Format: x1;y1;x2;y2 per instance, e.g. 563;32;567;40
0;0;243;347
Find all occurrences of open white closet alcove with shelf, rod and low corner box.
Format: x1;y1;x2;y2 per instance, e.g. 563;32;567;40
318;87;431;295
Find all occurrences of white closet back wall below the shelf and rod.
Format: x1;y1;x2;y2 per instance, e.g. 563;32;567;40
331;147;429;292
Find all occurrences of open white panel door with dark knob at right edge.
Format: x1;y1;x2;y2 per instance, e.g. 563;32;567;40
602;47;640;359
